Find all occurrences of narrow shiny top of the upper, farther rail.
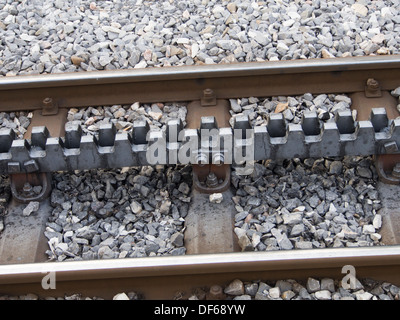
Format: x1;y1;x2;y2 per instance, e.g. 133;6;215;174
0;55;400;91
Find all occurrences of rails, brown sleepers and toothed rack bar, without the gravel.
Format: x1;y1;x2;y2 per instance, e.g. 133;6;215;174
0;56;400;299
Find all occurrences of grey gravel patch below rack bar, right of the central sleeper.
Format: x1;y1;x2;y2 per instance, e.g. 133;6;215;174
232;157;382;251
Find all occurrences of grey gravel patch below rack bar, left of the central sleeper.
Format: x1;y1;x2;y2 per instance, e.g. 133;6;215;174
45;166;192;261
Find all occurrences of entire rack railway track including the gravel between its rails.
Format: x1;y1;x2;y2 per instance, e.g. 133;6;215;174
0;57;400;299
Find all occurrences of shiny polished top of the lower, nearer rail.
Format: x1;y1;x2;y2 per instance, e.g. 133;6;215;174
0;245;400;285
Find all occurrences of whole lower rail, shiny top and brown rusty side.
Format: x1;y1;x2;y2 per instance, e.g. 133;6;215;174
0;245;400;299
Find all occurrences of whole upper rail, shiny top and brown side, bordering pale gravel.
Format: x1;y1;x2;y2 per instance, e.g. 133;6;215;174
0;55;400;111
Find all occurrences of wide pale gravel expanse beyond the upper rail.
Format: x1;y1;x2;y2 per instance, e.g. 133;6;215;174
0;0;400;76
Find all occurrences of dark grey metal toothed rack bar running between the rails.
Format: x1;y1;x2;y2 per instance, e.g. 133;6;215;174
0;108;400;174
